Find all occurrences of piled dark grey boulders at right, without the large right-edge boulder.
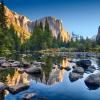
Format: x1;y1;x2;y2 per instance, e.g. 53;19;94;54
69;60;96;82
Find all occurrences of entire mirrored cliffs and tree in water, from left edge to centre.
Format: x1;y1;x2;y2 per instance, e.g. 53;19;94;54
0;57;69;86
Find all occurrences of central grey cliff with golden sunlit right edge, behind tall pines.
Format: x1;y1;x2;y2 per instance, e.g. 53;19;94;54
32;16;70;42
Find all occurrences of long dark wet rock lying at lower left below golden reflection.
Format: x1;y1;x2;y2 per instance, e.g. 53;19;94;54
8;84;29;94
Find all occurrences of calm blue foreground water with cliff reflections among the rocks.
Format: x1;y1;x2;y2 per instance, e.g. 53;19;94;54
0;55;100;100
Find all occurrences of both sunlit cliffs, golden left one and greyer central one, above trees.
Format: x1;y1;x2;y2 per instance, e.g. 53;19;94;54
2;6;71;42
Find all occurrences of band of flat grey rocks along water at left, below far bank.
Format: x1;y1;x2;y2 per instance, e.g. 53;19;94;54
0;57;45;74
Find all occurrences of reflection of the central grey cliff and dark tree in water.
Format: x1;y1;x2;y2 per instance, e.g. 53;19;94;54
30;59;69;85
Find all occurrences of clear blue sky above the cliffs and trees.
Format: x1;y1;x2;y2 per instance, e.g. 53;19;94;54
2;0;100;37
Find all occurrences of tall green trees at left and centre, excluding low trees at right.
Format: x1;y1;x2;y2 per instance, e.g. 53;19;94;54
0;0;64;54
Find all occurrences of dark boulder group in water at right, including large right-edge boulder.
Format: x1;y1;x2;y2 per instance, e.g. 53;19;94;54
69;60;100;90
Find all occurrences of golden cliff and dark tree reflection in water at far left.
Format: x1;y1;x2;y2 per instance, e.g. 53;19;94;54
0;69;29;86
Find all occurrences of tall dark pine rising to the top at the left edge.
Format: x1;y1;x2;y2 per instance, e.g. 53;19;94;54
0;0;9;52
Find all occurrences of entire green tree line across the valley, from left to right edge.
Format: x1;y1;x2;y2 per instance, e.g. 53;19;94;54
0;0;100;55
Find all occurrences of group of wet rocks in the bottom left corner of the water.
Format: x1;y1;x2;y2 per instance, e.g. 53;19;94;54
0;82;46;100
